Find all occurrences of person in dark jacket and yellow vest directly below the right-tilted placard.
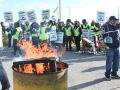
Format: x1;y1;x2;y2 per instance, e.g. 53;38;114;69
32;23;40;46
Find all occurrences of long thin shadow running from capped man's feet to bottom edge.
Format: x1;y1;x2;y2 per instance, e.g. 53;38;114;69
68;78;105;90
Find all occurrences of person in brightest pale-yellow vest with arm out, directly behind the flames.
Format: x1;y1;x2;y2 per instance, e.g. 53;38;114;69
39;22;51;45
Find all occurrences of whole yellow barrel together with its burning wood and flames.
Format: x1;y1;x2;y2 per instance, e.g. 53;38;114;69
12;42;68;90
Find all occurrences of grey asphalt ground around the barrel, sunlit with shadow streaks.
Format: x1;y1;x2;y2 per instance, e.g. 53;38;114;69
0;49;120;90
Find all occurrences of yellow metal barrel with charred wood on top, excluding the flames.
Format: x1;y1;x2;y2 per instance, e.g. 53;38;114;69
12;58;68;90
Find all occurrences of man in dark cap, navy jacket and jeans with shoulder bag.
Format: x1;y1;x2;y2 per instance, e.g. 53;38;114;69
103;16;120;81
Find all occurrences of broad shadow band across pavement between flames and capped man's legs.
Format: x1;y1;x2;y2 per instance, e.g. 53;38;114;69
61;51;105;63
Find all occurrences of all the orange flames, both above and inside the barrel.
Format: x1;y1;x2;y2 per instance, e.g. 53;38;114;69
13;40;65;74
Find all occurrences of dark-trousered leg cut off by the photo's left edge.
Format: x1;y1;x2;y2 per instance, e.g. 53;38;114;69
0;59;10;89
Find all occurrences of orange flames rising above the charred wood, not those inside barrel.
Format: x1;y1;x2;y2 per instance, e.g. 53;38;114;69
17;40;65;60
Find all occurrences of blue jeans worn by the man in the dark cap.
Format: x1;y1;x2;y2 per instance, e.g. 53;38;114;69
105;48;119;76
